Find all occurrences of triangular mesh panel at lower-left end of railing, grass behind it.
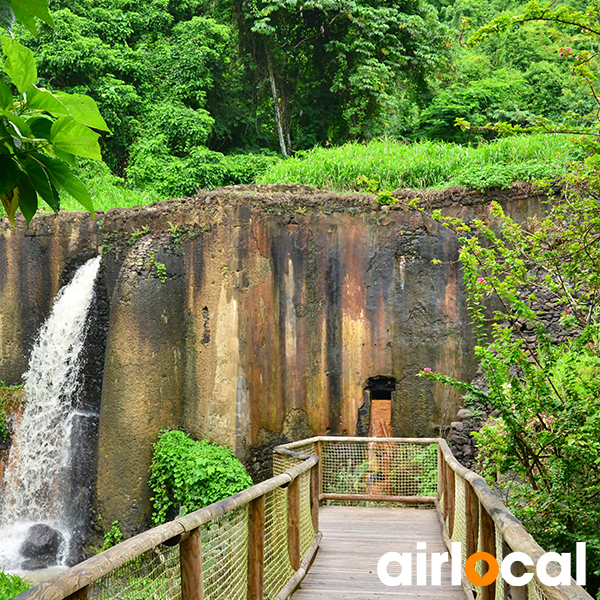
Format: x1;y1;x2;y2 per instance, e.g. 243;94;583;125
90;544;181;600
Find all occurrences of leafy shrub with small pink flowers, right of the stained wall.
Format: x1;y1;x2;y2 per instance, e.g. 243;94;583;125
421;191;600;593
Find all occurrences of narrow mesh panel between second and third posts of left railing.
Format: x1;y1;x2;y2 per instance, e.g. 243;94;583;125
263;488;294;600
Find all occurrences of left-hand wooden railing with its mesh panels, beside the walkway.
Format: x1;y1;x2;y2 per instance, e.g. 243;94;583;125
17;453;321;600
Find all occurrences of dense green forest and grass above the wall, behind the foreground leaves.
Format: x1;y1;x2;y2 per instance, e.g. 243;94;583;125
4;0;595;213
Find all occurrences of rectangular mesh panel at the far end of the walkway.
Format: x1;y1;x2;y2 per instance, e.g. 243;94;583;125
322;441;437;496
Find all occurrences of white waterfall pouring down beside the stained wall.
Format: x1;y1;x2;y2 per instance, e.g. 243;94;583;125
0;256;100;570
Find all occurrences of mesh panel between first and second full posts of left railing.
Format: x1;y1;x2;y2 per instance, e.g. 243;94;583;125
201;504;248;600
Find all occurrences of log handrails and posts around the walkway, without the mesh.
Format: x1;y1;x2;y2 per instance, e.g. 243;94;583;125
15;436;591;600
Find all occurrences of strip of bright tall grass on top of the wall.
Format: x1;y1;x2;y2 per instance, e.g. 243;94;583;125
259;134;583;191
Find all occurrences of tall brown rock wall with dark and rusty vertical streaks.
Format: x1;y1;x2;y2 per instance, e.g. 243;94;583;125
0;186;542;533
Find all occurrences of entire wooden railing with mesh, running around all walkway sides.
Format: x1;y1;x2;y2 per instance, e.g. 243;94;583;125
17;437;591;600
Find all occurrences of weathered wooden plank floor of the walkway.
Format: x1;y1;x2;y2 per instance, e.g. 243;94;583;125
292;506;466;600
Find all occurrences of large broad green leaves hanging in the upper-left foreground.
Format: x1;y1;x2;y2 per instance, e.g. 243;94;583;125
0;0;109;225
